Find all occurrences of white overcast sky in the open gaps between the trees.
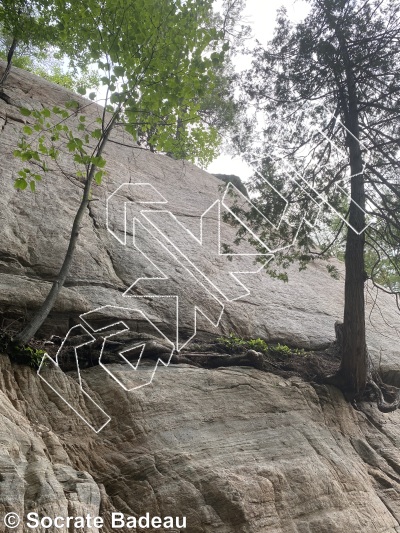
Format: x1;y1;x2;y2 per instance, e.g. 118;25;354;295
207;0;308;180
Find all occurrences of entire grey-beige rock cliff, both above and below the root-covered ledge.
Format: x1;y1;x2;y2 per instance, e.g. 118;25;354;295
0;63;400;533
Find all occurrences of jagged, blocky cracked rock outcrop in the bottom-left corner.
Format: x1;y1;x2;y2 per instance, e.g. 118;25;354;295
0;357;101;531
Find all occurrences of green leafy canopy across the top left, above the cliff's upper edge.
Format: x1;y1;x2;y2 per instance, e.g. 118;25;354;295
0;0;229;164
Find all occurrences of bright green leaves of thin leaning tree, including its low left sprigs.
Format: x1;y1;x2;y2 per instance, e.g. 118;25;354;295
10;0;228;186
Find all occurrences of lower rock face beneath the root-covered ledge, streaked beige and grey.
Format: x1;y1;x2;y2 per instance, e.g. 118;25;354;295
0;356;400;533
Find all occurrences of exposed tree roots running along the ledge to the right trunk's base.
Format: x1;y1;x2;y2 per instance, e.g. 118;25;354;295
4;316;400;413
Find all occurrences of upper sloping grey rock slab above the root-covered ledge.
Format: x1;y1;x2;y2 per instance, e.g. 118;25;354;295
0;61;399;370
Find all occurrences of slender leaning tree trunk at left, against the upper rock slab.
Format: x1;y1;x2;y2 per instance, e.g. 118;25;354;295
13;111;118;345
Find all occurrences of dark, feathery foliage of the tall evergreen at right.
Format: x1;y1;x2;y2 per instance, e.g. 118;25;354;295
239;0;400;290
